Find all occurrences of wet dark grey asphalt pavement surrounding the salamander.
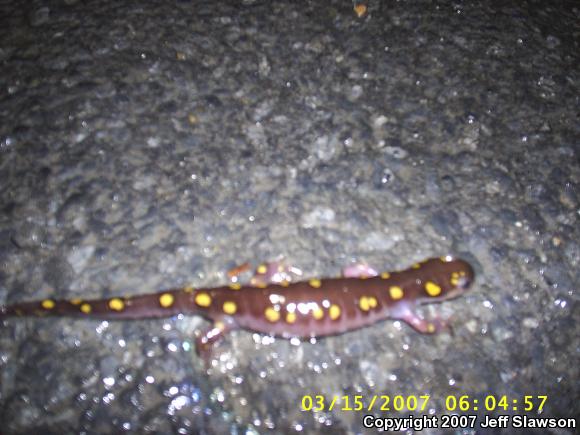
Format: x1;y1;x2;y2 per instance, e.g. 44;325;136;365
0;0;580;435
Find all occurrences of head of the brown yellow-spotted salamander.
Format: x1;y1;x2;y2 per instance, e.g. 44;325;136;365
420;255;475;303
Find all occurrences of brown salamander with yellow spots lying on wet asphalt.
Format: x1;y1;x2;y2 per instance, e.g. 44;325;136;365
0;256;474;353
